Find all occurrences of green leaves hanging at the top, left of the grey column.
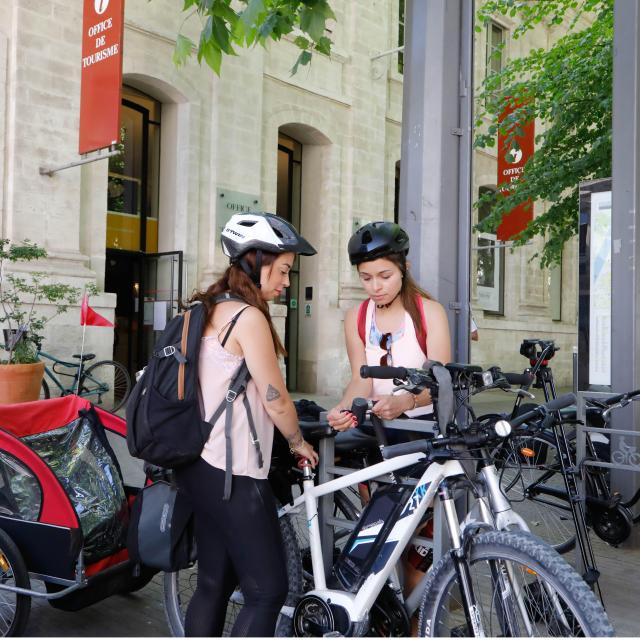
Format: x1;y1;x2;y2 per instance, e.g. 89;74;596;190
173;0;335;75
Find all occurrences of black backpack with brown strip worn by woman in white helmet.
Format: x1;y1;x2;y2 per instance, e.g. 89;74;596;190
127;294;263;499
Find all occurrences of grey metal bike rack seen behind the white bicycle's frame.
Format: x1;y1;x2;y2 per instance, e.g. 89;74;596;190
316;411;448;575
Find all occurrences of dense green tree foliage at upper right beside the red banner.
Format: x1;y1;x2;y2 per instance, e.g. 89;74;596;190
475;0;613;266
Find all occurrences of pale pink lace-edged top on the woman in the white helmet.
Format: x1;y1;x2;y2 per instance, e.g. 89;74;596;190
199;336;274;480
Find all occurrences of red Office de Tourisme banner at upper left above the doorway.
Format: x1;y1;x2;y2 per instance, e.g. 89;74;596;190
78;0;124;153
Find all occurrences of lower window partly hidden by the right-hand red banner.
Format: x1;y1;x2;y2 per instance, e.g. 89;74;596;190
476;187;504;315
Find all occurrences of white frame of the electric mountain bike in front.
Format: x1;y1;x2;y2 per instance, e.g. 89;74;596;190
279;453;465;624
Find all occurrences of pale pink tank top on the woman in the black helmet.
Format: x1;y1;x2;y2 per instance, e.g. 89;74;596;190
364;300;433;418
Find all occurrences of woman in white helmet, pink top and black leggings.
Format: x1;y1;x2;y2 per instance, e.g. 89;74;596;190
177;213;318;636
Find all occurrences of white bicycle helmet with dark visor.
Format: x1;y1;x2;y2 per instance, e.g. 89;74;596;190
220;212;316;287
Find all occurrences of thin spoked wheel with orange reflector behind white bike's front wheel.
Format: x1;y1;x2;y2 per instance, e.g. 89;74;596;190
499;433;576;553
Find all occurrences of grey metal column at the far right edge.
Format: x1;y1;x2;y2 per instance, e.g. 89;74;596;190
611;0;640;543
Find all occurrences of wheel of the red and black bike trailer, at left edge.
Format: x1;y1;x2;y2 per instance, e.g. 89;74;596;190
0;529;31;636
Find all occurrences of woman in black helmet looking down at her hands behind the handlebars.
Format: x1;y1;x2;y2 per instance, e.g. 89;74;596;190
328;222;451;431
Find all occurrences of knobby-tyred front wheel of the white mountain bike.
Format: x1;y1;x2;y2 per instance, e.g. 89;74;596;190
419;531;613;638
